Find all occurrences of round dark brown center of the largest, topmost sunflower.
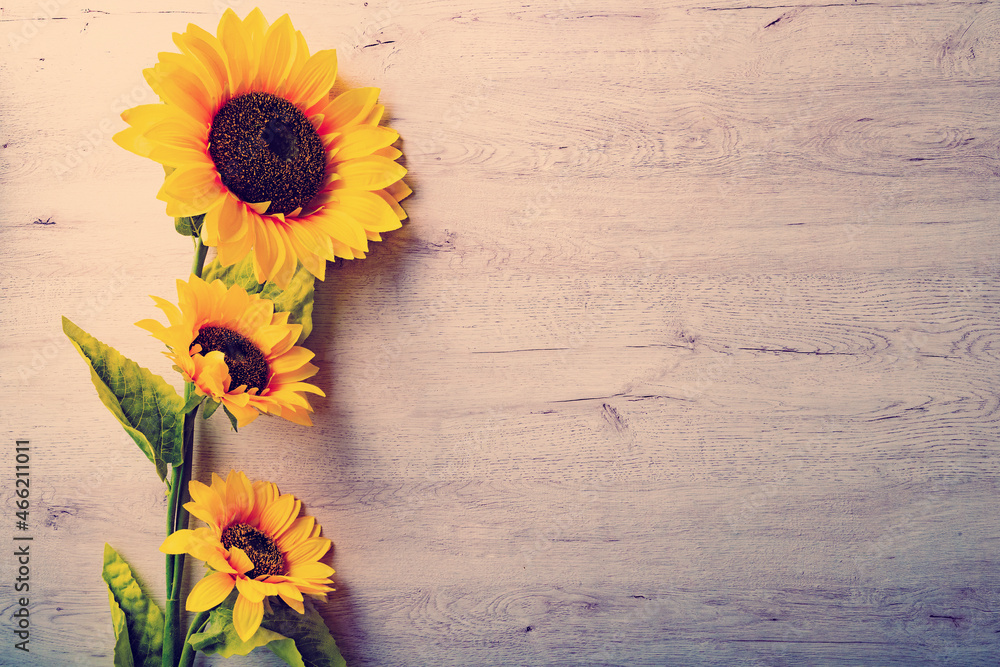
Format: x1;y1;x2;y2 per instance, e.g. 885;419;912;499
208;93;326;213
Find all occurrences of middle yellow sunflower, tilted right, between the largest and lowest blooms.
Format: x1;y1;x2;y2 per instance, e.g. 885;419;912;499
136;275;325;427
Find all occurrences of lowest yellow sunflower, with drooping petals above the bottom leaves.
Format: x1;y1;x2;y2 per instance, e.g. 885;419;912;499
160;470;333;641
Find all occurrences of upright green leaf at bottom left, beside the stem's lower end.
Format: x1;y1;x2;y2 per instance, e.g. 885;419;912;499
102;544;163;667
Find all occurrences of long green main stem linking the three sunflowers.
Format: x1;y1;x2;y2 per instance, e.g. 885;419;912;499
162;236;208;667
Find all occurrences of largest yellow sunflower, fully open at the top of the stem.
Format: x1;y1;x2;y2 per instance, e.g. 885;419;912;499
114;9;411;287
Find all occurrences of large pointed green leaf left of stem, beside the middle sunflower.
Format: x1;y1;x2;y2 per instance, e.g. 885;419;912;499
63;317;184;480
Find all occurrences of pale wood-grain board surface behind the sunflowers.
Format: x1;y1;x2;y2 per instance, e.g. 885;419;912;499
0;0;1000;666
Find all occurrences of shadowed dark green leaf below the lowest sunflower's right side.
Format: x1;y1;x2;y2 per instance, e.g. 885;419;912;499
261;600;347;667
